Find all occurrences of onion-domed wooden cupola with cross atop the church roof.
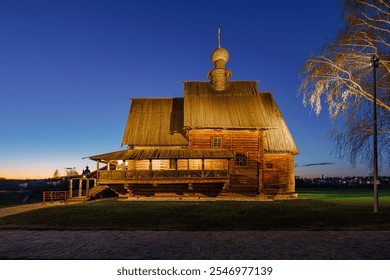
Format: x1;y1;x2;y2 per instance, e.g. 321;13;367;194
208;28;232;91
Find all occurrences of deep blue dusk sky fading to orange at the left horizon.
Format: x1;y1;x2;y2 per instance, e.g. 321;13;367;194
0;0;384;178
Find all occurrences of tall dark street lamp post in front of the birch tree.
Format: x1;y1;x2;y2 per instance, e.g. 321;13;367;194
370;55;379;213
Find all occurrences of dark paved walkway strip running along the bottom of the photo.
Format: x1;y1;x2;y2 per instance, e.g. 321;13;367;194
0;230;390;260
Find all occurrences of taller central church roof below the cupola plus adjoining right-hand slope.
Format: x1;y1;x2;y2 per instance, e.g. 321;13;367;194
184;81;298;154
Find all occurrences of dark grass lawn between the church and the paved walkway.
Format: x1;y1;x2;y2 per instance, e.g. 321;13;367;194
0;187;390;230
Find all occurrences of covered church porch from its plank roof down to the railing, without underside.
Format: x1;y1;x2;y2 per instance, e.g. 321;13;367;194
91;149;233;184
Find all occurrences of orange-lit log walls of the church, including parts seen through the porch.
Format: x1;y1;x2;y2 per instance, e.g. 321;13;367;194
99;129;295;196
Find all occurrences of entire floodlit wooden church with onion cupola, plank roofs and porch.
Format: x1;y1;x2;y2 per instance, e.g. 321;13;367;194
89;31;298;199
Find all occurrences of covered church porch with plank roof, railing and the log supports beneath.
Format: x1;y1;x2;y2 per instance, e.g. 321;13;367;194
85;148;233;196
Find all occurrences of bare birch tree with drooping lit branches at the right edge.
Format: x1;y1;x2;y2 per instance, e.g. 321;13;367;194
299;0;390;170
